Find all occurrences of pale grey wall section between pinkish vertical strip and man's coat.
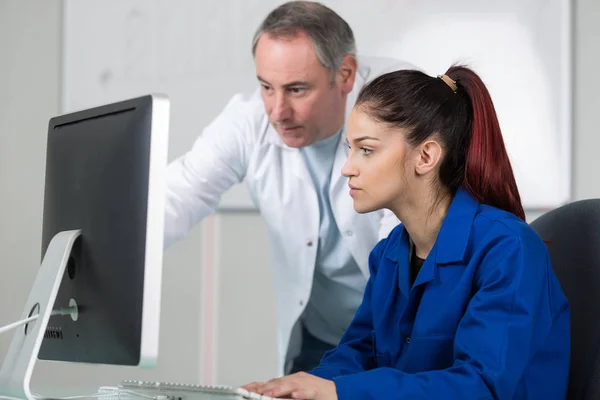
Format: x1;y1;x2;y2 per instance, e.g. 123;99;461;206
216;212;277;385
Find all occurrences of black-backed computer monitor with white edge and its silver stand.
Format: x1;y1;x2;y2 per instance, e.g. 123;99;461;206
0;95;170;398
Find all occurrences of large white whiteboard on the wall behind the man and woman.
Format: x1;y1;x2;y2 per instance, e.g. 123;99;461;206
61;0;572;210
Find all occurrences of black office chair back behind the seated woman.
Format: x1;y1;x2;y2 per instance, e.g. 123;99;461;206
531;199;600;400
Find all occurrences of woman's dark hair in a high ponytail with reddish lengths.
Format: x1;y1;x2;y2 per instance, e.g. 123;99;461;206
356;66;525;220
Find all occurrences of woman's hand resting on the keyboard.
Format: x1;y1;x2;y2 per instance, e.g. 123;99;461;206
243;372;337;400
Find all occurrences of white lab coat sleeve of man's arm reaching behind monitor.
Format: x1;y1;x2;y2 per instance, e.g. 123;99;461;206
164;95;256;247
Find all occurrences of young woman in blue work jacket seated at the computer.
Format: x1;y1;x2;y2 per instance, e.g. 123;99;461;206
247;66;570;400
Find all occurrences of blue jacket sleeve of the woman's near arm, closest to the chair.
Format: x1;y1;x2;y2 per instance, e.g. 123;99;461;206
334;233;570;400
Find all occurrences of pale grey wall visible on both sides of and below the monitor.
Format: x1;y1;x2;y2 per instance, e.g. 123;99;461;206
0;0;206;385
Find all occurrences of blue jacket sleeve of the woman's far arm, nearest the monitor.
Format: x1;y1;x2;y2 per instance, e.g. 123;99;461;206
309;239;387;380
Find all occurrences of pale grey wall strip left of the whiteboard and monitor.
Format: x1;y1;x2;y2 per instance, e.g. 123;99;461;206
0;0;60;382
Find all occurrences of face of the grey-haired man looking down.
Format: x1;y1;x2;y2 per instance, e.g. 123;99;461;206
254;33;354;147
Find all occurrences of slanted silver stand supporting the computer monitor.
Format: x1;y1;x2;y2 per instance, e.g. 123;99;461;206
0;230;81;400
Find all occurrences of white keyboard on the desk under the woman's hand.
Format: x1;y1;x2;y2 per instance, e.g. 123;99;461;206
99;380;284;400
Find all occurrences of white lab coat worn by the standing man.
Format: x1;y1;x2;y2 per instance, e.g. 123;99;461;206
165;54;415;373
